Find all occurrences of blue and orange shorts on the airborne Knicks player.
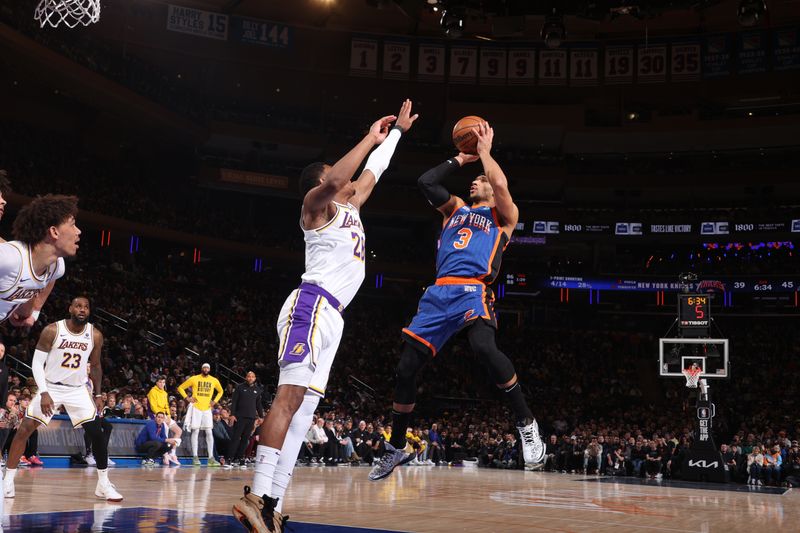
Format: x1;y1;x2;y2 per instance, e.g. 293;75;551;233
403;278;497;355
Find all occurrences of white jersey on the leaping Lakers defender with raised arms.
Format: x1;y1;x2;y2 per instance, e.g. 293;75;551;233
301;202;366;307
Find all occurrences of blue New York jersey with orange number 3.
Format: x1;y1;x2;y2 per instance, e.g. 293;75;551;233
436;205;508;284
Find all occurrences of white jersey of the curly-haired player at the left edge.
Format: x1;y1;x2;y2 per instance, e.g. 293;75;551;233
0;241;65;322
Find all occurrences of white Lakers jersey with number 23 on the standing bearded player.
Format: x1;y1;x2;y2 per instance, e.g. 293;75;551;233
44;320;94;387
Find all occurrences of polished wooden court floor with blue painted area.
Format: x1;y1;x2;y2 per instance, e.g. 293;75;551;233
3;466;800;533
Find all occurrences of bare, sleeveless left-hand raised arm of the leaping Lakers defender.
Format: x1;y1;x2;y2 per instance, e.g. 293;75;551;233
303;115;397;214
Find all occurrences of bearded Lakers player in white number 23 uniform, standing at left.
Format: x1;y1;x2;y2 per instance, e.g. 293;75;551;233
3;296;122;502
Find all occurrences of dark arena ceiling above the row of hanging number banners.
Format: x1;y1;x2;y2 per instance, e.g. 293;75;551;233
175;0;800;40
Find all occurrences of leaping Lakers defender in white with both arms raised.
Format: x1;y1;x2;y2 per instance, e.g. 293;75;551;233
233;100;417;533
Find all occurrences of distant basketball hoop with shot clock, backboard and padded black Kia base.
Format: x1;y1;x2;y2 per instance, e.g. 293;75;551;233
658;274;729;483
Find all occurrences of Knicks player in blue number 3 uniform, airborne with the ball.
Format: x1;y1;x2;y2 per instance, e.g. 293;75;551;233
369;122;544;481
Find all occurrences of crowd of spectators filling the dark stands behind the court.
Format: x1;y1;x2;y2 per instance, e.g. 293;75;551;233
0;245;800;482
